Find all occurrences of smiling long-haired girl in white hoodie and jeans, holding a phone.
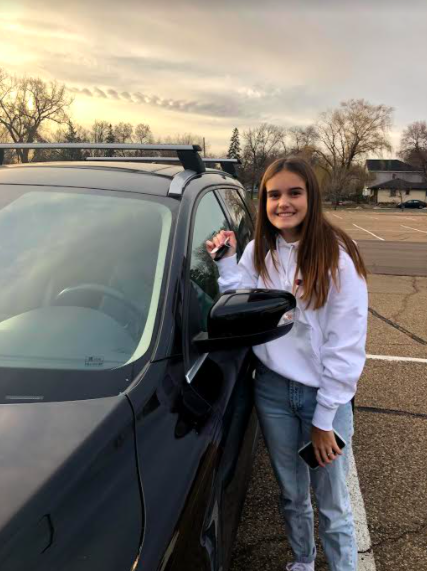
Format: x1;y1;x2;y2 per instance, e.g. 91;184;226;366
206;157;368;571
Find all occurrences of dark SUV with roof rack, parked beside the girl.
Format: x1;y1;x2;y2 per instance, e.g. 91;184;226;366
0;145;295;571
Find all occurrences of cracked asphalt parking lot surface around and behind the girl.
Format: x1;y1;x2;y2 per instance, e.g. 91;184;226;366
231;209;427;571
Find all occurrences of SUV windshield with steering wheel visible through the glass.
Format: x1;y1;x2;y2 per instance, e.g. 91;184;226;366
0;185;172;371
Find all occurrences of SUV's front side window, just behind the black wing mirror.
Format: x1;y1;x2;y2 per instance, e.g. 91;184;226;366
189;192;230;333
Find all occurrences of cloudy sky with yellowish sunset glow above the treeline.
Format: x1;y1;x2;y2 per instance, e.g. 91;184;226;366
0;0;427;156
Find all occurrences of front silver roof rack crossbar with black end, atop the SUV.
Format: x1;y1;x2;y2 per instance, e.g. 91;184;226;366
0;143;206;173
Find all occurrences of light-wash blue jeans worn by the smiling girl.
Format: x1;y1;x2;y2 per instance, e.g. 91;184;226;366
255;363;357;571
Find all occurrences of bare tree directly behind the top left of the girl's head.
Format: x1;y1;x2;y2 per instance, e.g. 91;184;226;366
242;123;286;197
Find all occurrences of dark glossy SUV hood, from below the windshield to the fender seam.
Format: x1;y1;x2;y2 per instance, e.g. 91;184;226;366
0;395;143;571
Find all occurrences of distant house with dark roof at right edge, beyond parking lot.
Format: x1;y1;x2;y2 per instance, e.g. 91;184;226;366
366;159;427;204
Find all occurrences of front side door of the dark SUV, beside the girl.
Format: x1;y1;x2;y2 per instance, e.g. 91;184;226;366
181;190;257;569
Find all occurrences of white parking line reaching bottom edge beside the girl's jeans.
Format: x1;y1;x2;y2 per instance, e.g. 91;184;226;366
347;449;376;571
